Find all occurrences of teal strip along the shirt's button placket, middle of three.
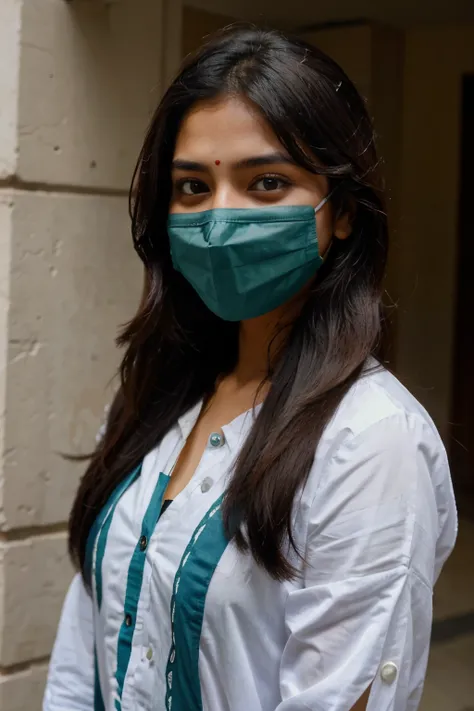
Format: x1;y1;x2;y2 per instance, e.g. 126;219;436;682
115;474;169;711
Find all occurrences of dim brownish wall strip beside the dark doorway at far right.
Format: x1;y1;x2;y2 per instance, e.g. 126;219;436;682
397;25;474;435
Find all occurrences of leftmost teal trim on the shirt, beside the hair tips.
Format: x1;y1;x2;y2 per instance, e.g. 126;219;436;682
84;464;142;711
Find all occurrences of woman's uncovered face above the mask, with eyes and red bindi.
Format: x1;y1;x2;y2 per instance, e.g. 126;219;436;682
170;98;350;255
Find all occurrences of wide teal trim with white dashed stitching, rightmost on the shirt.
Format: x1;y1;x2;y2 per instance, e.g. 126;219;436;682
166;496;229;711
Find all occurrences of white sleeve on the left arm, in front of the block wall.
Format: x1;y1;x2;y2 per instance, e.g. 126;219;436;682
43;575;94;711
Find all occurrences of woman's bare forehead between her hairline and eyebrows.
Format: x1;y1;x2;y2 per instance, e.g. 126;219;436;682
175;97;282;161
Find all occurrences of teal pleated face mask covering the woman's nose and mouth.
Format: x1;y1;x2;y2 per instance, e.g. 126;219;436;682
168;197;329;321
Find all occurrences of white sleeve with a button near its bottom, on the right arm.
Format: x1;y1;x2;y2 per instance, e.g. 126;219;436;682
277;414;456;711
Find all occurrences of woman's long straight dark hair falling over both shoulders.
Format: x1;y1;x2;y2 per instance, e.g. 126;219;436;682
70;28;388;580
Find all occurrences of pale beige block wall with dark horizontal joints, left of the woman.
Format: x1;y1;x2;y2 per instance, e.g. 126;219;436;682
0;0;181;711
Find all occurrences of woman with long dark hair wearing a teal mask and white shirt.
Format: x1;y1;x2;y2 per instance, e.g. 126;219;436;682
44;29;456;711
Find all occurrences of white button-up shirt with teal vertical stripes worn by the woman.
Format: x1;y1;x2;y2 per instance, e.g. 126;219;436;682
43;368;456;711
